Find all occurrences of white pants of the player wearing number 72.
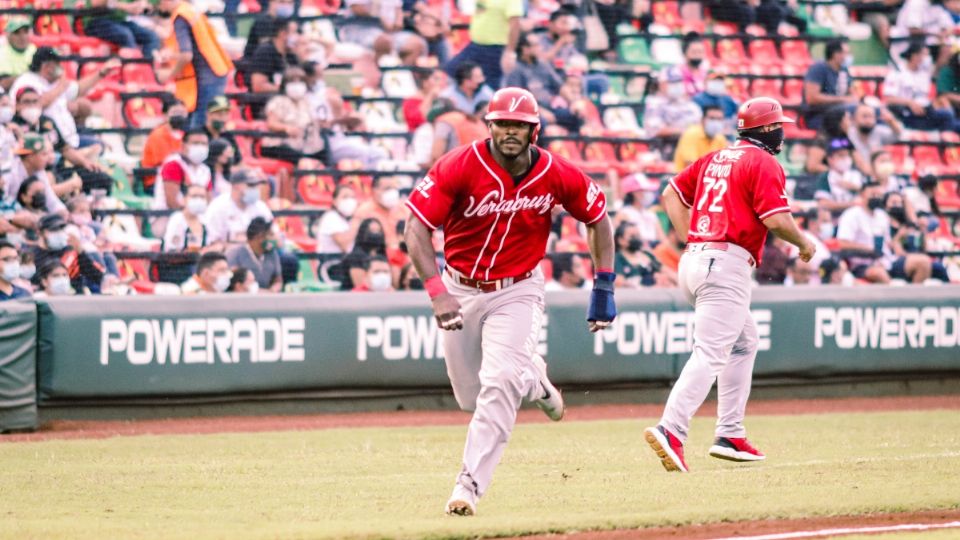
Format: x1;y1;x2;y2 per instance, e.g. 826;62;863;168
660;245;758;441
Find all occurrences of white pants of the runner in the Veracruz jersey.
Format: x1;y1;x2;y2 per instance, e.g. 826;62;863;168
443;269;544;496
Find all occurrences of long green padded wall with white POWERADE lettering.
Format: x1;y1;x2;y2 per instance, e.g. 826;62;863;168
38;287;960;404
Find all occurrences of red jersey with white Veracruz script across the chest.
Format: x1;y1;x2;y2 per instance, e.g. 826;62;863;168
407;139;607;281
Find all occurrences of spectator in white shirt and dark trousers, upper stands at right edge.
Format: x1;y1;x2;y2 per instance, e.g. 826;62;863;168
883;42;956;131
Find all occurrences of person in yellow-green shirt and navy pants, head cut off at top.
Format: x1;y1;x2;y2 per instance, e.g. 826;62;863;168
444;0;523;89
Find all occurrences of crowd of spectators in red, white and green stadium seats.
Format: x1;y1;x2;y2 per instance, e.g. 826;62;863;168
0;0;960;299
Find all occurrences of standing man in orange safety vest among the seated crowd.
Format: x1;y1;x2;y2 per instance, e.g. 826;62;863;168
157;0;233;128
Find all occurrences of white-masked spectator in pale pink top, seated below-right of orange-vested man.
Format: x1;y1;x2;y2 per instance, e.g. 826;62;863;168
260;67;327;168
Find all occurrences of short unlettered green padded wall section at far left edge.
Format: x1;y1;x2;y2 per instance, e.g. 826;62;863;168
0;300;37;431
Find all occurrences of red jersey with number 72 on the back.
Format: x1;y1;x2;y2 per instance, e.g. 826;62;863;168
670;141;790;264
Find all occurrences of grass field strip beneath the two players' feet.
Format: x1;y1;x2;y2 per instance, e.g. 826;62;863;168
0;411;960;539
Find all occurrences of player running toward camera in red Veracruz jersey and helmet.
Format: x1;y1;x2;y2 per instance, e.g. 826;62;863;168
405;88;616;516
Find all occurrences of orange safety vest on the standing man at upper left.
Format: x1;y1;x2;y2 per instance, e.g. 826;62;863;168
166;2;233;112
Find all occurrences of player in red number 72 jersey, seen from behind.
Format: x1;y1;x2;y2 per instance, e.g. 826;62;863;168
644;97;816;472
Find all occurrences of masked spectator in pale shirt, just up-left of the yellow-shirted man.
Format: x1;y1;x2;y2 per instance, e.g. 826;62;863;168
643;69;703;137
